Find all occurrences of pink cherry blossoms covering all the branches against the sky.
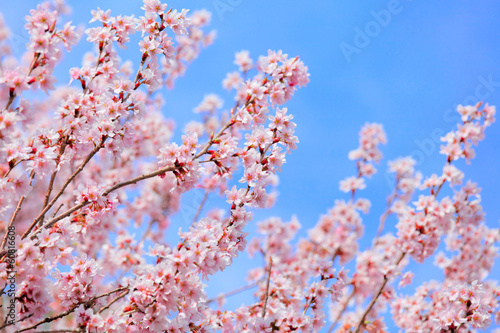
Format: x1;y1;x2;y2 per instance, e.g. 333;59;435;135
0;0;500;333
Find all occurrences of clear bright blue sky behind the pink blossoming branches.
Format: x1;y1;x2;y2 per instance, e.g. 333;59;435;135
0;0;500;330
